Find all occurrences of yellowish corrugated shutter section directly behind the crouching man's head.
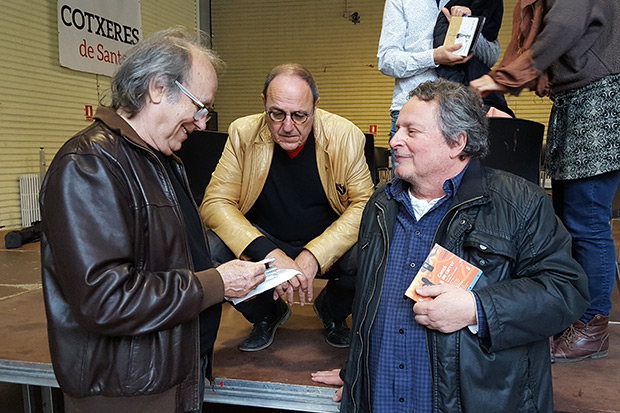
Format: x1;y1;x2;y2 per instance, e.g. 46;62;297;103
212;0;550;146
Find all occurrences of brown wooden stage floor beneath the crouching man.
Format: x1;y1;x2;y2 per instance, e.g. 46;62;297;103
0;224;620;412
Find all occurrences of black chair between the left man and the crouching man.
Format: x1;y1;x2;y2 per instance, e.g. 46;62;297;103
176;130;228;205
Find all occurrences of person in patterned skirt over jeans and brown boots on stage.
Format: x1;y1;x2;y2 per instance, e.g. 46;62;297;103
470;0;620;362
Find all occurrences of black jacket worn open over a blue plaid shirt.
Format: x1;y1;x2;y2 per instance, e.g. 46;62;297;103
341;161;589;412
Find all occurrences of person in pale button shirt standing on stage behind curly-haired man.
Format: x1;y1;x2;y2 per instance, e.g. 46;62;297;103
377;0;500;168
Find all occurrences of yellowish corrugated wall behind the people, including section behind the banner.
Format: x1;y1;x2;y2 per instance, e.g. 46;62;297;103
0;0;550;228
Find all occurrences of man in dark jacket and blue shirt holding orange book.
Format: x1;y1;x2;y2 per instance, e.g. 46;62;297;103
314;80;589;412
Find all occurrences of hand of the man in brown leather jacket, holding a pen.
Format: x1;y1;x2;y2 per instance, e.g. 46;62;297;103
216;260;265;298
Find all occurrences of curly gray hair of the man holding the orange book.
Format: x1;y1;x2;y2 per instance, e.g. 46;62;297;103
409;78;489;159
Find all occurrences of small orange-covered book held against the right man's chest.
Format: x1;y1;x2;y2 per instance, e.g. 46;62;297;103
405;244;482;301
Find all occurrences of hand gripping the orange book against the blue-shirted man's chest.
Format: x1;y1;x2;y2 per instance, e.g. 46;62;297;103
413;284;476;333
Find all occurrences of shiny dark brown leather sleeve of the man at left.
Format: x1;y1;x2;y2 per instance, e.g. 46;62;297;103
41;153;211;336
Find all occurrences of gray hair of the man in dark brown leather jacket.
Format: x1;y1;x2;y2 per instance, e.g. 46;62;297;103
111;27;224;118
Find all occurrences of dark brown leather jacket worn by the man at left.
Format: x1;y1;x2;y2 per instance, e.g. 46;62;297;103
40;108;224;410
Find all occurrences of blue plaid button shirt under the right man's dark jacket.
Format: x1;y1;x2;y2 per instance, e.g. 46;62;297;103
369;168;467;413
